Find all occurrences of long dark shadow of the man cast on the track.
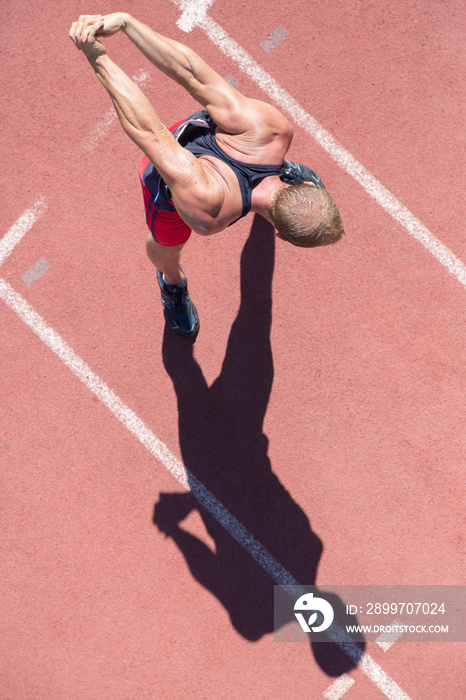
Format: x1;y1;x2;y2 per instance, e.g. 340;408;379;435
154;215;358;676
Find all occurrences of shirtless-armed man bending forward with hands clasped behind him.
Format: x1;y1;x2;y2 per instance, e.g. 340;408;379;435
70;12;344;337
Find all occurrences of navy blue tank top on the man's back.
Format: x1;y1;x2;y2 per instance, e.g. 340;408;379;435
173;110;283;226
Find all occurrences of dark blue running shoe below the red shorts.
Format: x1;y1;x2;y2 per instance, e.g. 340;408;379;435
157;268;199;338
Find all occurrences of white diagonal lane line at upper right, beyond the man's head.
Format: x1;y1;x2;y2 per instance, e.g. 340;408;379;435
172;0;466;286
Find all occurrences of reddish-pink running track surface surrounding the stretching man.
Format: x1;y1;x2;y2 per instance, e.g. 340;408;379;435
0;0;466;700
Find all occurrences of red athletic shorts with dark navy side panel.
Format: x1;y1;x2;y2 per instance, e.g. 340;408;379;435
139;119;191;246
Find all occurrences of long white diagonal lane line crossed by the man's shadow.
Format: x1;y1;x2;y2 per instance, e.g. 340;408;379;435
0;278;410;700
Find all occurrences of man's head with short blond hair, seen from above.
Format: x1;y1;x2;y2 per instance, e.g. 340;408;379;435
272;183;344;248
